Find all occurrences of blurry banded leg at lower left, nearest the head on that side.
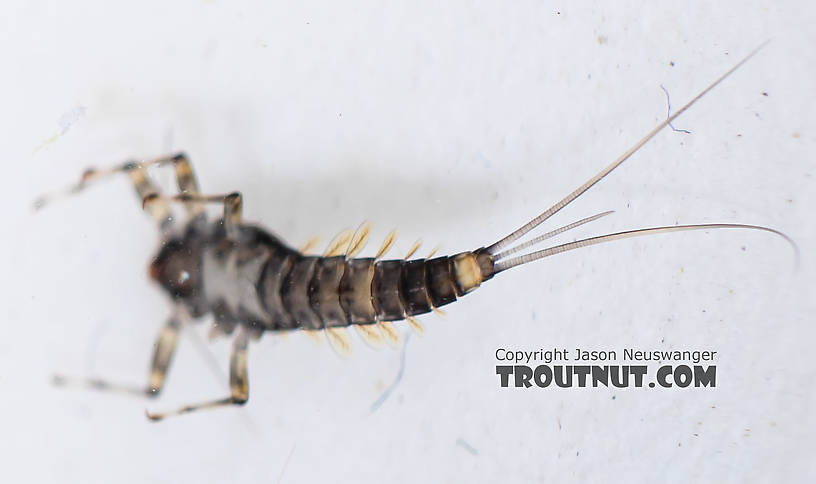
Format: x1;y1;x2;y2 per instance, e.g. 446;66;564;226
53;316;181;397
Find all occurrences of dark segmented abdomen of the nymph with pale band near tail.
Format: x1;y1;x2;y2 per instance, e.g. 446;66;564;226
258;247;492;330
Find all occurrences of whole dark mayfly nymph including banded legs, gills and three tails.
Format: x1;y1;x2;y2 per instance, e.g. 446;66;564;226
38;45;793;420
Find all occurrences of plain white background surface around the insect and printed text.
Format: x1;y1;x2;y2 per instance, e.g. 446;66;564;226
0;0;816;482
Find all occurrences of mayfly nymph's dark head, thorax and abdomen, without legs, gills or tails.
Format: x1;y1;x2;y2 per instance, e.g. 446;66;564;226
150;208;493;333
